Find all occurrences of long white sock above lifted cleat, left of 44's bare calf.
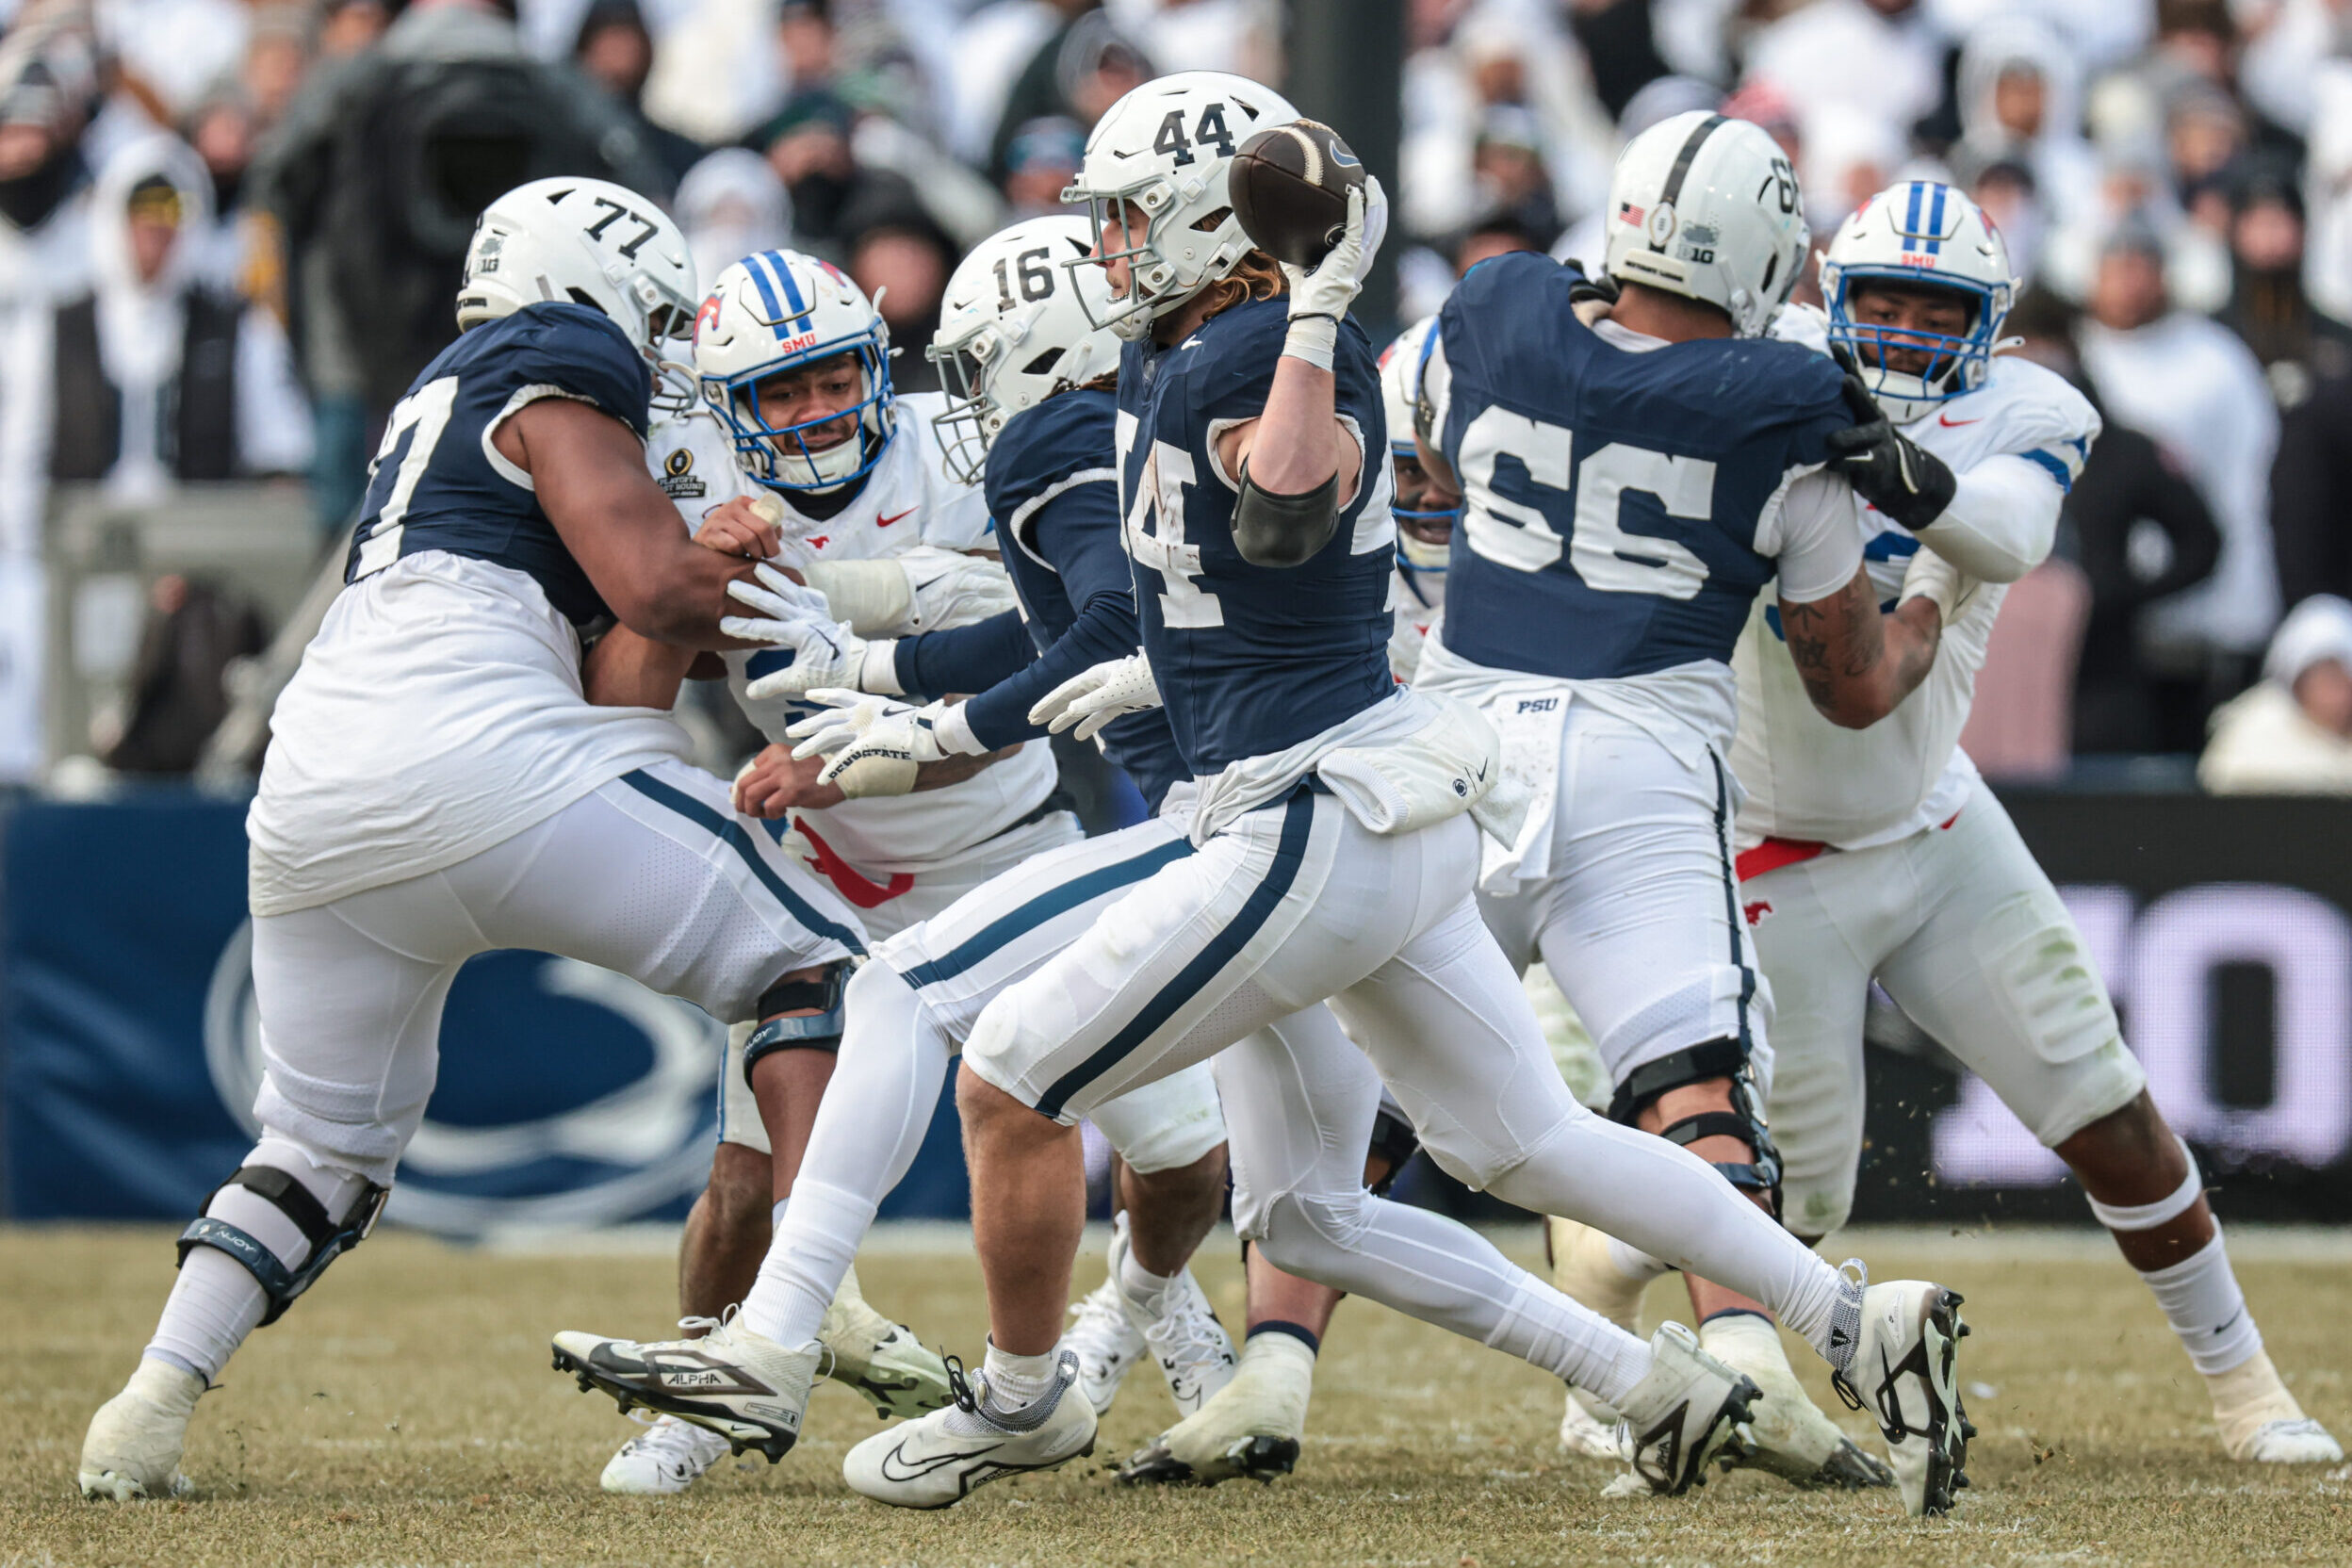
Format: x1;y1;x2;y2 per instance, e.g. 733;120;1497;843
743;964;948;1345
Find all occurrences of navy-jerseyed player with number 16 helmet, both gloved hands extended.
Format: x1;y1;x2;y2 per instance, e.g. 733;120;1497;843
560;217;1234;1455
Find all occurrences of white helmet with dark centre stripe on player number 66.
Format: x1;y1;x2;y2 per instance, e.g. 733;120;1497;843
1602;108;1806;338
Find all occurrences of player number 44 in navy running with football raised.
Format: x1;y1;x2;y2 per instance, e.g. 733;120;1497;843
813;73;1959;1507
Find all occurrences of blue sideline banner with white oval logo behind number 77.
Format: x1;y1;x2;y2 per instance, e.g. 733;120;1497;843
0;790;969;1236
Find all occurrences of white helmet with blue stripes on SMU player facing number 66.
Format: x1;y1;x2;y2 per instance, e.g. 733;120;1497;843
1821;179;2018;426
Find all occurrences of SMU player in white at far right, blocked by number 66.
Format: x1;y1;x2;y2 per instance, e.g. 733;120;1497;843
1571;181;2343;1464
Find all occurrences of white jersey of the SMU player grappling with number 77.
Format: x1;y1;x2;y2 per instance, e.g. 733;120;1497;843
646;393;1061;877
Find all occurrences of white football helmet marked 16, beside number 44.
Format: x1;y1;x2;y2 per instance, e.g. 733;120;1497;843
924;212;1119;484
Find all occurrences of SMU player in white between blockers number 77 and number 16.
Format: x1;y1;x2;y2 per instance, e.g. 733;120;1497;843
580;247;1233;1493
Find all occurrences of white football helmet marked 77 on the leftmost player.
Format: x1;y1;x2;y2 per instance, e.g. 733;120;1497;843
456;179;698;365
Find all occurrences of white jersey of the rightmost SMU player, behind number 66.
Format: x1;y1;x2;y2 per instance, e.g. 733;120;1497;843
1731;350;2100;849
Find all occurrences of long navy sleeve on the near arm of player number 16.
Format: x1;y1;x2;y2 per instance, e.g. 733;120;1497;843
964;484;1143;750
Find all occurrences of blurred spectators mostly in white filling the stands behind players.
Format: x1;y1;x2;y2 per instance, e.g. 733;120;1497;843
0;0;2352;788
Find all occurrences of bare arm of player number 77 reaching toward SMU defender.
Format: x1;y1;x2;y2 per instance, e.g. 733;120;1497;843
492;398;755;649
